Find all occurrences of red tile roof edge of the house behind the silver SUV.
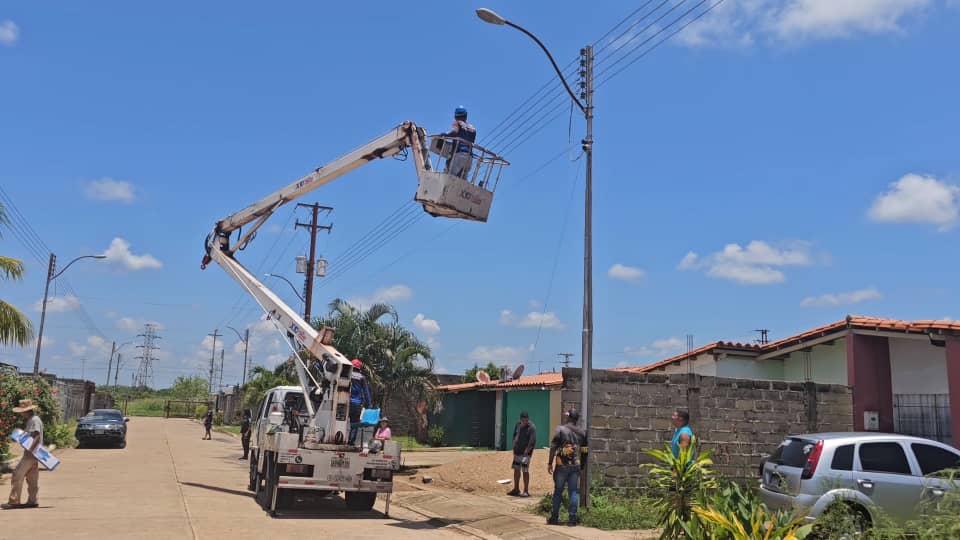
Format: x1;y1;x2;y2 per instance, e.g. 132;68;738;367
613;315;960;373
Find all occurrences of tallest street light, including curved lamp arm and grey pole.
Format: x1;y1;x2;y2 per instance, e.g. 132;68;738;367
477;8;593;506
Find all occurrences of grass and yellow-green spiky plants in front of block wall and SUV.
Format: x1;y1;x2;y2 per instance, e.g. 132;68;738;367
533;447;960;540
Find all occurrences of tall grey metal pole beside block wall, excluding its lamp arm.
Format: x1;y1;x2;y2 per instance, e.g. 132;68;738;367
580;45;593;508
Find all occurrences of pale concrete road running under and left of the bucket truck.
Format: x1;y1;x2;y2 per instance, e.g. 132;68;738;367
0;418;463;540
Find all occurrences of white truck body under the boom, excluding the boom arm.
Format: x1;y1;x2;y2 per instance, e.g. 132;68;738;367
248;386;400;515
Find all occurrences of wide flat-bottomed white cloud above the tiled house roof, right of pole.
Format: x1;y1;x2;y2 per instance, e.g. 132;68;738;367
677;240;813;285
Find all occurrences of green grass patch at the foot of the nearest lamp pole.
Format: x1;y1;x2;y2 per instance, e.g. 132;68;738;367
533;487;657;531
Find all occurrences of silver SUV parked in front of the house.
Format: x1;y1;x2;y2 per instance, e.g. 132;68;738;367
760;433;960;522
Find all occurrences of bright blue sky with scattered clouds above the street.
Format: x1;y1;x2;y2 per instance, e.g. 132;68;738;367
0;0;960;386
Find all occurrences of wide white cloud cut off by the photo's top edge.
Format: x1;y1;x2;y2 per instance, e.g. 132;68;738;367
676;0;933;47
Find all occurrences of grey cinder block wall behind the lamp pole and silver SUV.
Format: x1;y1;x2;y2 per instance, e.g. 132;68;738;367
562;369;853;488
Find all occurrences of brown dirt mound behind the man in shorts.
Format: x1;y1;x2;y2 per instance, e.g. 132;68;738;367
415;450;553;498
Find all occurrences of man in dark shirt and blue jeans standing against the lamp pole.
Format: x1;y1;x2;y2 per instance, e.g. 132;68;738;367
547;409;587;526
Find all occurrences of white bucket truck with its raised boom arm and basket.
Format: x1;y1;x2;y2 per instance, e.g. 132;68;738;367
201;122;509;515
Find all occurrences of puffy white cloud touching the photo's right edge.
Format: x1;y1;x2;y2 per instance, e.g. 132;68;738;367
867;174;960;232
